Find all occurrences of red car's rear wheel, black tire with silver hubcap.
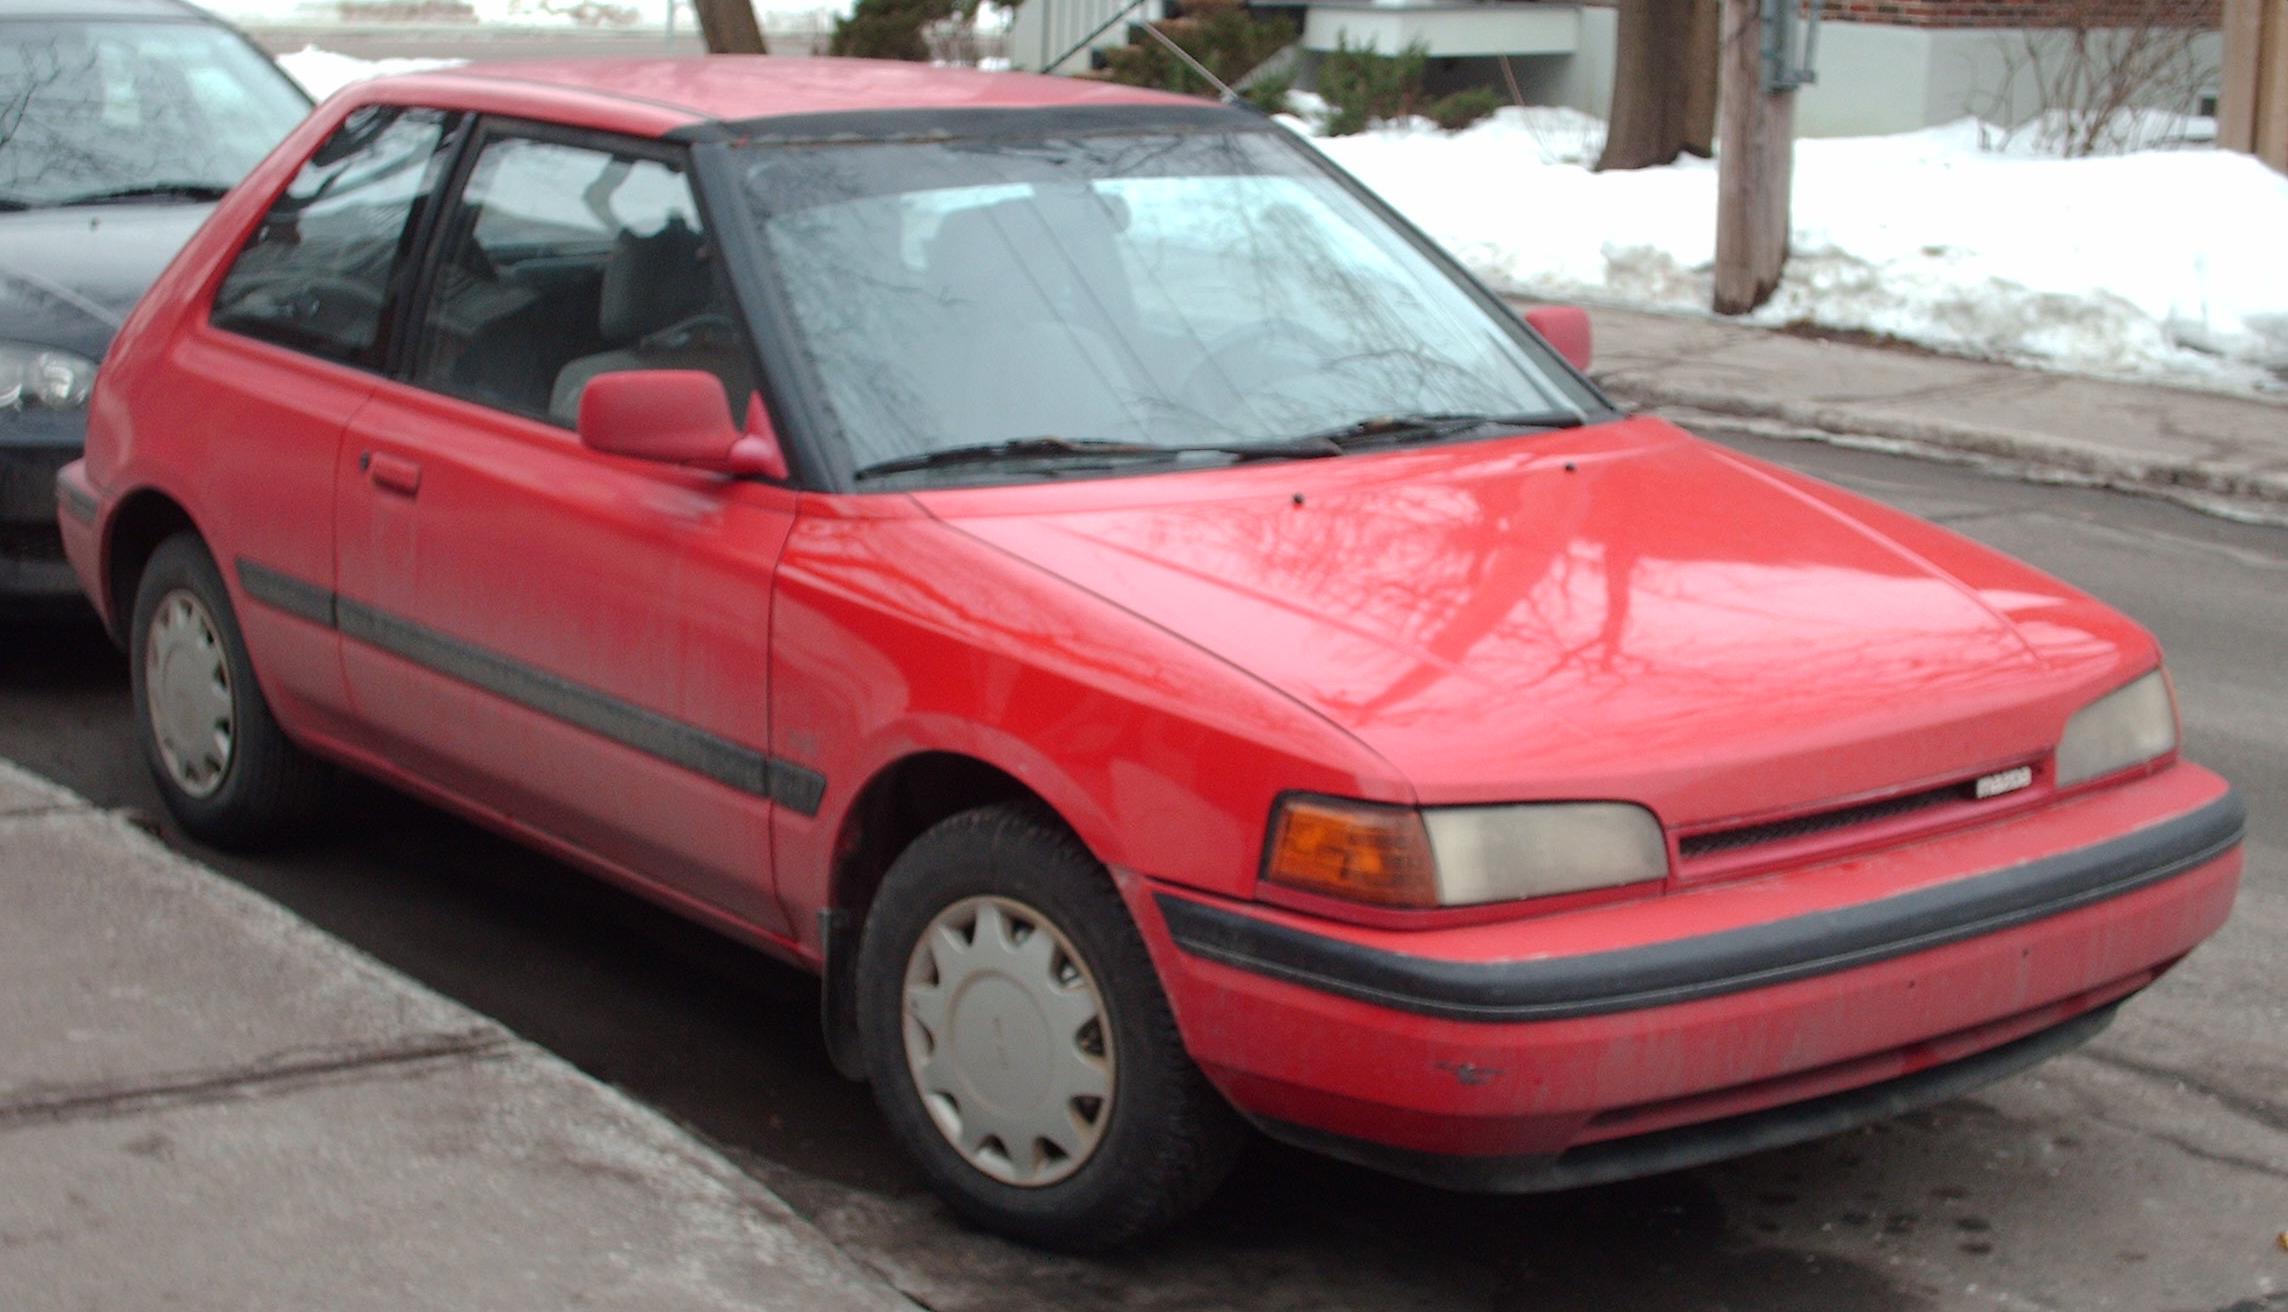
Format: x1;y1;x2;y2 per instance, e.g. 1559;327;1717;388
128;534;329;852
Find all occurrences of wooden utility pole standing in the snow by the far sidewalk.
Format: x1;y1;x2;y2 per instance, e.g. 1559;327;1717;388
1716;0;1819;314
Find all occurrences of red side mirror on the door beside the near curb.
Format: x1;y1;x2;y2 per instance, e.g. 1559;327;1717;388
579;369;787;479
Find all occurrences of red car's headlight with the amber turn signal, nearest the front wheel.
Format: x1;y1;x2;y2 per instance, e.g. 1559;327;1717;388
1263;797;1668;907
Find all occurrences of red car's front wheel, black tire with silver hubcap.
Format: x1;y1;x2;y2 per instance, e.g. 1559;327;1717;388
858;806;1245;1252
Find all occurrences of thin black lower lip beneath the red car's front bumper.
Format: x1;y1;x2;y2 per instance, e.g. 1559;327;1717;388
1256;1003;2121;1193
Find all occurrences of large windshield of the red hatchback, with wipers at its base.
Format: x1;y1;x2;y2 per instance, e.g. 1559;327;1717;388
739;128;1604;472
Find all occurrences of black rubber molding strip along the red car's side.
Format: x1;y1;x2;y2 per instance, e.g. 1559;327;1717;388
238;559;826;815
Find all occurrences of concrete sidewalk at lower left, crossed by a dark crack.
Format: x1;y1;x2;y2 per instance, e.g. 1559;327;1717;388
0;762;913;1312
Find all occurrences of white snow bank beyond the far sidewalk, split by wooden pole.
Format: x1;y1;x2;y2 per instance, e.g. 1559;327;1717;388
1288;105;2288;387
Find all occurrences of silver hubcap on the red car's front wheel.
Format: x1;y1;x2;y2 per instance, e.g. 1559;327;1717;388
906;898;1112;1186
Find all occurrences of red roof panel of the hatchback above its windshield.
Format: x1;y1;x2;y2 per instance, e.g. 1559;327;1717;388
391;57;1199;124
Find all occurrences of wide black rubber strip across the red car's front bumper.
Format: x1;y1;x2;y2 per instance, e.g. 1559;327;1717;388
1155;792;2247;1021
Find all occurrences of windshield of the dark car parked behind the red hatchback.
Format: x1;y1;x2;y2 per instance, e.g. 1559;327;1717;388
0;21;309;208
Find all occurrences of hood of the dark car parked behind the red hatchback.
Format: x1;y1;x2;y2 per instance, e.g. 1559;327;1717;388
0;204;213;359
